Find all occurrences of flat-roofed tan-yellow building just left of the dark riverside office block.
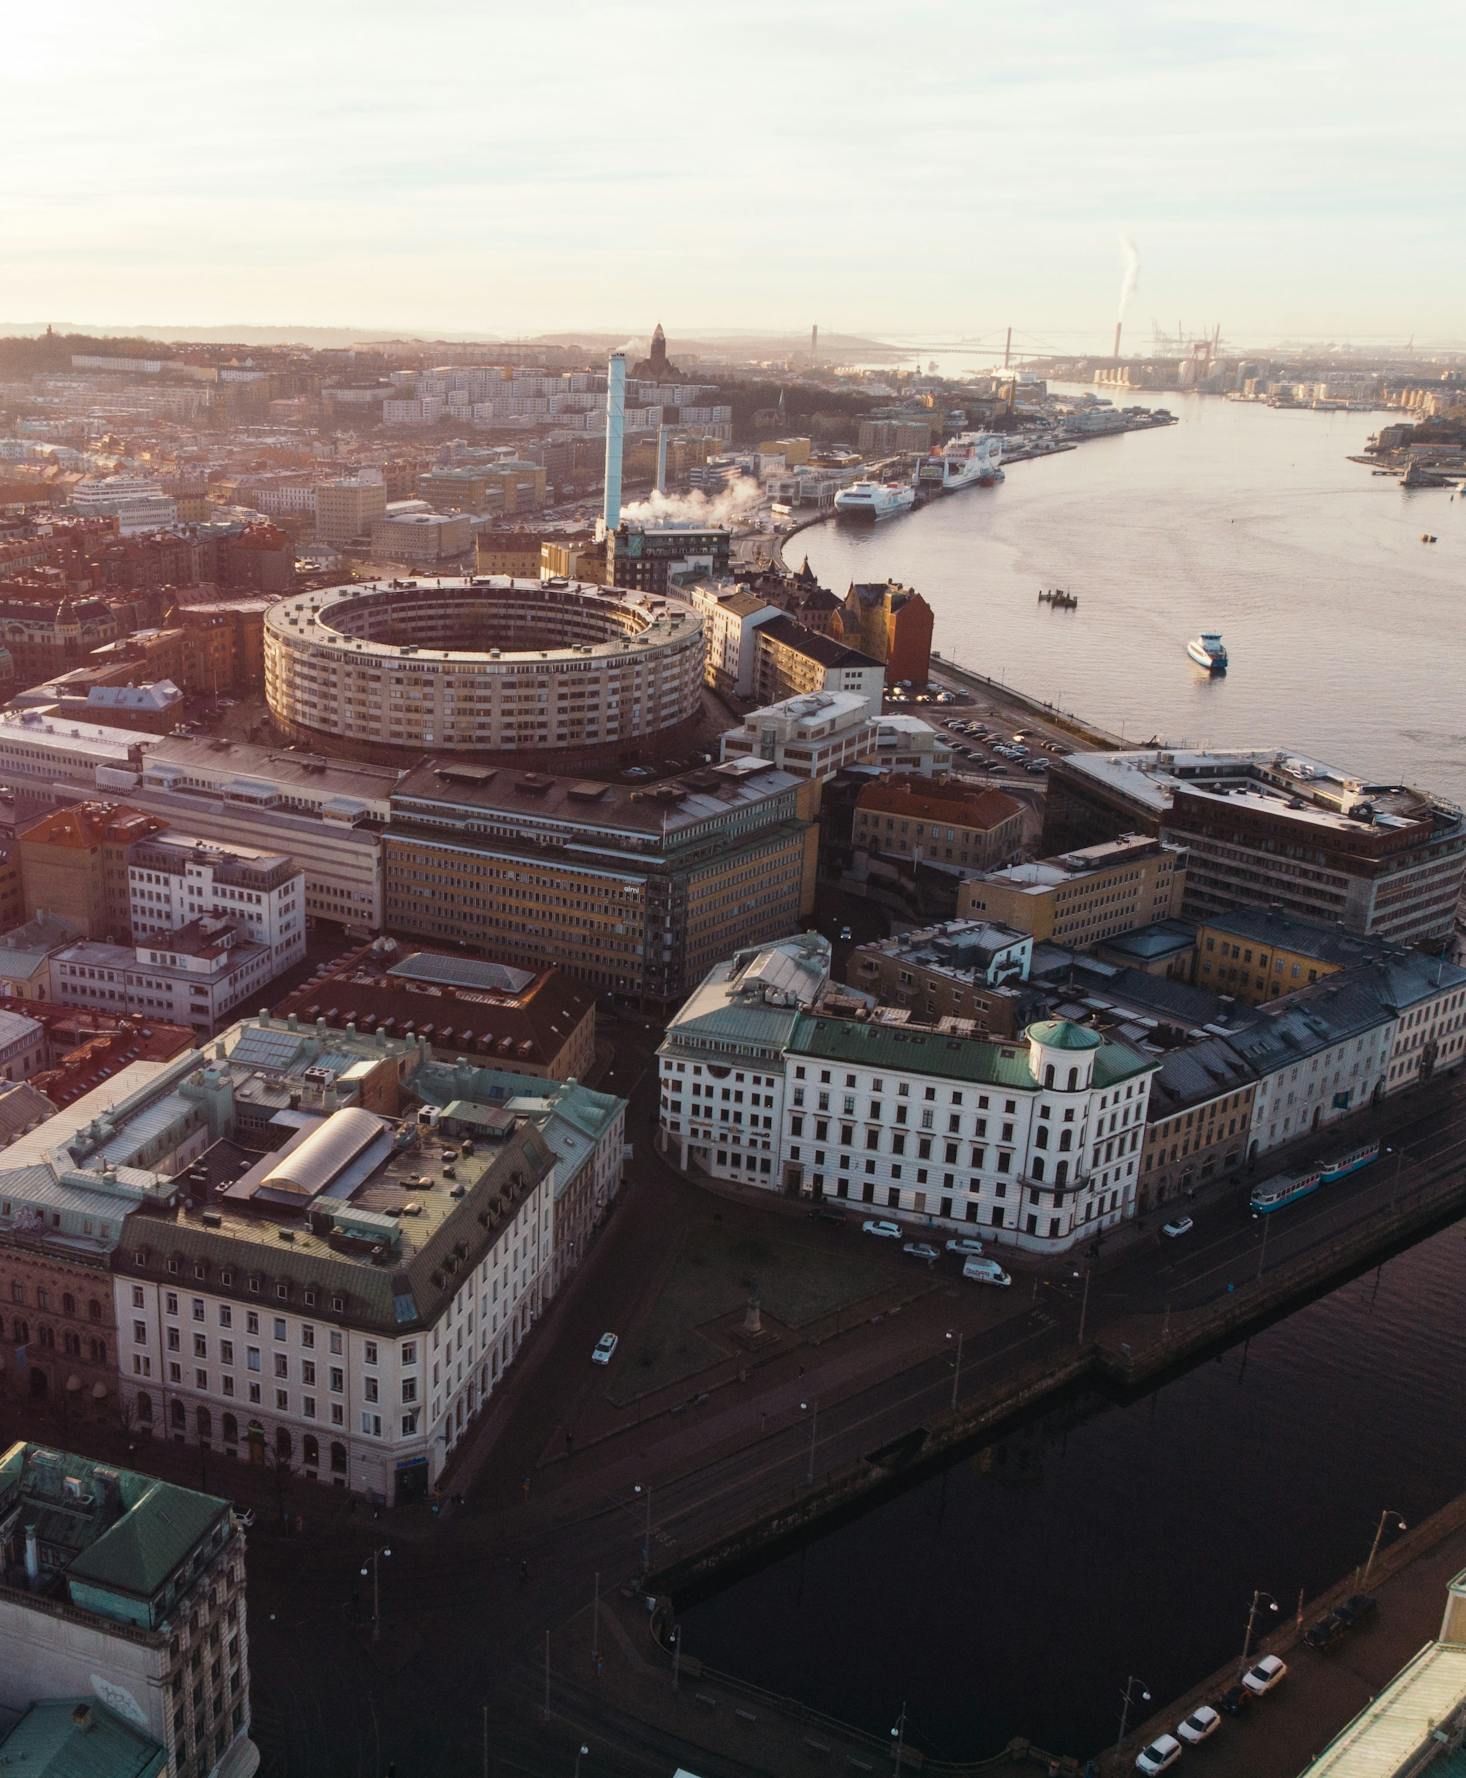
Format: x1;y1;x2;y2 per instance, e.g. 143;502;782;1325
958;834;1185;951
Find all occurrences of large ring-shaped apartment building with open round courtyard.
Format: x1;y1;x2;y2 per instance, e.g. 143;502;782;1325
265;574;704;768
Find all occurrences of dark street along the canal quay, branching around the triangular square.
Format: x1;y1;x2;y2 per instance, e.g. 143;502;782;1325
229;1052;1466;1778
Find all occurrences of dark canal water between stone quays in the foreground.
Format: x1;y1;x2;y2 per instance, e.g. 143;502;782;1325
682;1227;1466;1758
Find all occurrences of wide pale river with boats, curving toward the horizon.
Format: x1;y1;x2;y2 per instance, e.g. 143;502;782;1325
789;393;1466;800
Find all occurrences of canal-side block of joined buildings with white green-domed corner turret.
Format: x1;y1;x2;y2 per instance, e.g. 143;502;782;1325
659;923;1466;1252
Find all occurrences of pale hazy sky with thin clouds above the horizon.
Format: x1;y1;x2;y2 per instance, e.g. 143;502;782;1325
11;0;1466;348
